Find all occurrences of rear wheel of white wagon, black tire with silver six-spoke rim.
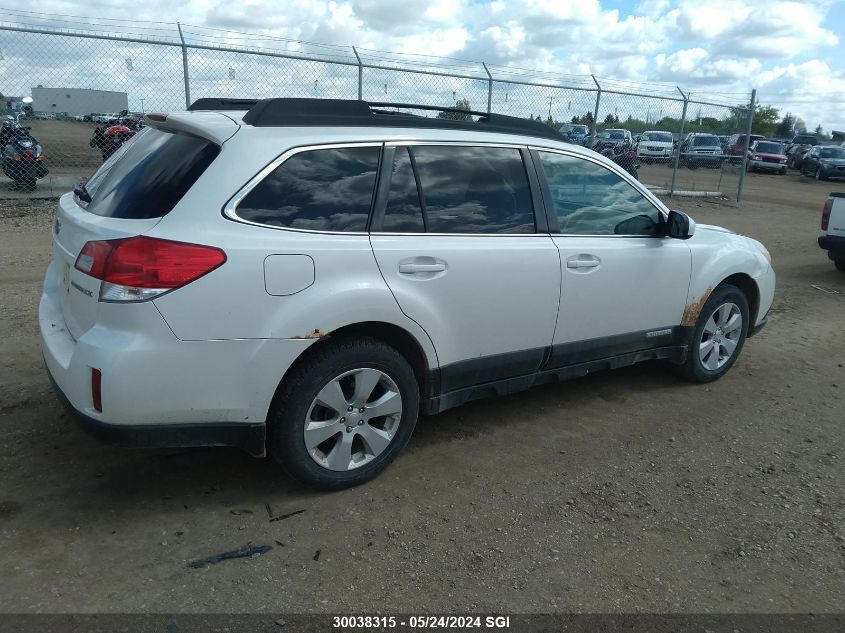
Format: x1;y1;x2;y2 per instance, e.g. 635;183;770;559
267;338;420;490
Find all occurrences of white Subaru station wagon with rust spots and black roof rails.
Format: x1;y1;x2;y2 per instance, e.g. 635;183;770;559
39;99;775;488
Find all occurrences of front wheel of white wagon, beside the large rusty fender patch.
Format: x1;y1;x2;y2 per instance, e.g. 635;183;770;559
681;284;750;383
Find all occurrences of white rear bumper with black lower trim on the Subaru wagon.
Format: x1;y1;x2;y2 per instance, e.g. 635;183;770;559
39;264;314;454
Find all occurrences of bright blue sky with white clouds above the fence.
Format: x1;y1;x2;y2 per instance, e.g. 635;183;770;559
0;0;845;131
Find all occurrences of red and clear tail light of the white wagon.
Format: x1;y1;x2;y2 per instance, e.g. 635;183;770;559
75;236;226;301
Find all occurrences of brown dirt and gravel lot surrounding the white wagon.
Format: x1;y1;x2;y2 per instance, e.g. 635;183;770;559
0;175;845;613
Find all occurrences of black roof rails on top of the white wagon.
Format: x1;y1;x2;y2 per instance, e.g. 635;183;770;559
231;98;566;141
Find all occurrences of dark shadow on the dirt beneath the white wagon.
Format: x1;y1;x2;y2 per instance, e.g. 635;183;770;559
26;362;684;514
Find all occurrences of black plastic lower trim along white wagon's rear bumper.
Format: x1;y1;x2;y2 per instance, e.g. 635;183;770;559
47;367;266;457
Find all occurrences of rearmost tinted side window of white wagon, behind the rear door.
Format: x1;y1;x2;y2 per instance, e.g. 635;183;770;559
237;146;381;232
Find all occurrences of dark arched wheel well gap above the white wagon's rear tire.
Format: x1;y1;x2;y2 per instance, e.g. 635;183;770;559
271;321;431;420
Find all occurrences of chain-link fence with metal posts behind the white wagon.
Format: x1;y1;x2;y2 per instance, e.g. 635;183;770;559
0;20;753;200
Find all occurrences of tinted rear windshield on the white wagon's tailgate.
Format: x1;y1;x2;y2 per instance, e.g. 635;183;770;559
85;127;220;220
